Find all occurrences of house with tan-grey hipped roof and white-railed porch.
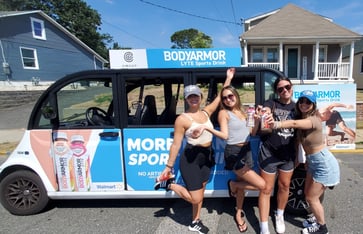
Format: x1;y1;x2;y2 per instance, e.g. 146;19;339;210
240;4;362;83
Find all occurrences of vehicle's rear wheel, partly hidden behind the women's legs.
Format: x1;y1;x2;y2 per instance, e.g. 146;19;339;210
285;167;309;215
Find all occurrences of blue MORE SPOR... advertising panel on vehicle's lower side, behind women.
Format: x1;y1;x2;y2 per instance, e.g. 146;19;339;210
124;128;235;191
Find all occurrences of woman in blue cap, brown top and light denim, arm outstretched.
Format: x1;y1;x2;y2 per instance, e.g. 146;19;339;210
270;90;340;234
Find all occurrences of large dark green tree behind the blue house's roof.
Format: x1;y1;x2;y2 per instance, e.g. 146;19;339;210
0;0;113;58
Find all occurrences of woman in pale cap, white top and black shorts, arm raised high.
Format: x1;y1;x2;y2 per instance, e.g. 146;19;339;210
155;68;235;233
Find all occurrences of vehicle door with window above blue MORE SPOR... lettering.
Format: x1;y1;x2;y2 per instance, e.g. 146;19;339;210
120;70;189;191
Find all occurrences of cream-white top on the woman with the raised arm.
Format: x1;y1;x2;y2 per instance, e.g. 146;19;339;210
183;111;213;145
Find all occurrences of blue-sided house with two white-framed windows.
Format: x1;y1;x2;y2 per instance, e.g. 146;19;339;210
0;10;108;85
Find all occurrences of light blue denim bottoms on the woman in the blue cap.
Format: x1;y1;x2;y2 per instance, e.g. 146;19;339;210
306;148;340;187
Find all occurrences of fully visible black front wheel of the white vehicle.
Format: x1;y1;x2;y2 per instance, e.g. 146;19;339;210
0;170;49;215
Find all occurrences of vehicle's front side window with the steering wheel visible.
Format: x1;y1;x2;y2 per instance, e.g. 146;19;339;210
57;79;113;128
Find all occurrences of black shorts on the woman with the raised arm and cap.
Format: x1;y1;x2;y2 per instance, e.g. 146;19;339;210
180;144;212;191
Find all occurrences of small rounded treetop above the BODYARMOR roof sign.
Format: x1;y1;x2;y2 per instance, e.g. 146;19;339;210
170;28;213;49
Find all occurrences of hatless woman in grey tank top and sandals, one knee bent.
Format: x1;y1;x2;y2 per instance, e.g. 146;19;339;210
203;86;265;233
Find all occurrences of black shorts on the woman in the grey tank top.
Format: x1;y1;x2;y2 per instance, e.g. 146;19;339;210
224;144;253;171
